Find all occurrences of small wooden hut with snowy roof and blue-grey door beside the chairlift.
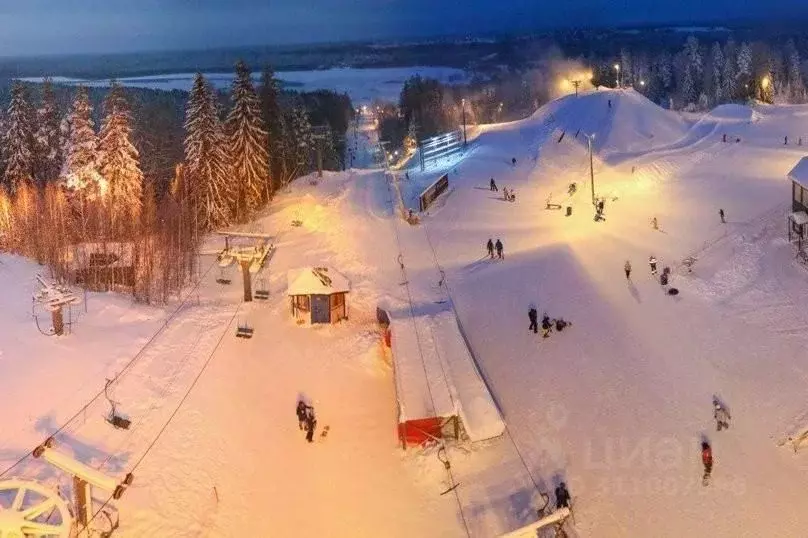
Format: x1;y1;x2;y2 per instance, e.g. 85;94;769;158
286;267;351;323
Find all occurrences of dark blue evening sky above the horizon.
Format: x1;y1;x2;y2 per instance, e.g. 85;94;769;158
0;0;808;55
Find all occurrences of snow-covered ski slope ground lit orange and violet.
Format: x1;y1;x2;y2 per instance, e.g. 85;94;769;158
0;86;808;538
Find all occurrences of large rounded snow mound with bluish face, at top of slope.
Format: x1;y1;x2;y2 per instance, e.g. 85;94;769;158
532;89;689;154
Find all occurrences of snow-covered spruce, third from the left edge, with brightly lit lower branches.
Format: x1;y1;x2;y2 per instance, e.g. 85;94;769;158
62;87;108;201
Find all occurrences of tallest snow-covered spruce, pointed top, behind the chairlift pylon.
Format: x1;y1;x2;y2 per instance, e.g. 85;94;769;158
225;61;269;221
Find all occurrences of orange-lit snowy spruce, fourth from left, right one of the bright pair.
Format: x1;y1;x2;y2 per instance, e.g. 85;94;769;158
98;82;143;231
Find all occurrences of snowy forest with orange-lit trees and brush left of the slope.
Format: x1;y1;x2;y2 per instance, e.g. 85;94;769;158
0;62;354;302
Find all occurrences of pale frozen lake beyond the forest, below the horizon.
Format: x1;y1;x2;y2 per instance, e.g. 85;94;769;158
23;66;468;103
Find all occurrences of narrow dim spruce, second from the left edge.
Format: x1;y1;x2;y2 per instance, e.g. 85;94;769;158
34;78;62;183
